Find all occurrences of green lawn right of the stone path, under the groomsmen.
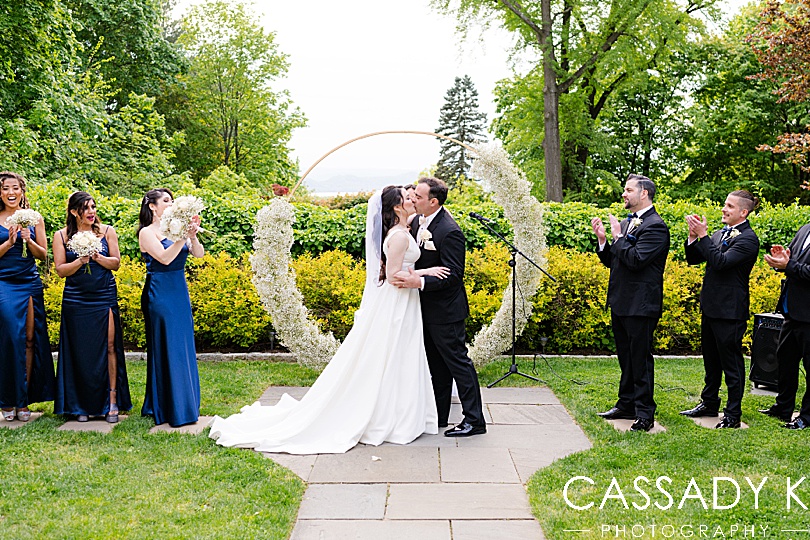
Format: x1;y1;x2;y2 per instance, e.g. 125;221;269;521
480;358;810;539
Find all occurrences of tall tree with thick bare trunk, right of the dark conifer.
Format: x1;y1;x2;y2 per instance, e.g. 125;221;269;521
432;0;718;201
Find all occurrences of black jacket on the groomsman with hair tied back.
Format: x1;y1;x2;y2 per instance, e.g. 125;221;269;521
684;221;759;321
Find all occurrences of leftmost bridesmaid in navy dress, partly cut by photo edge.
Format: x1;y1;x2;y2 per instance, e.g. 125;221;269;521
0;171;54;422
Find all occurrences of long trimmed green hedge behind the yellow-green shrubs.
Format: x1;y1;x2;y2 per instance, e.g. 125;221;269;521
29;180;810;260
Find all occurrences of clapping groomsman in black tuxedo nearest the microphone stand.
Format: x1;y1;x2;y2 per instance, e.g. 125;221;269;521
591;174;669;431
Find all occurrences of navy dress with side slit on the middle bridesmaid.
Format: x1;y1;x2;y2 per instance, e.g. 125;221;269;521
53;231;132;416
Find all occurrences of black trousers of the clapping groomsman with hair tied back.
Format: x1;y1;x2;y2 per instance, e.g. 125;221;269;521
700;315;747;418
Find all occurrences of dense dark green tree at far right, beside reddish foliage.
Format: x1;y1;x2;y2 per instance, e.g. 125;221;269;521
661;6;810;203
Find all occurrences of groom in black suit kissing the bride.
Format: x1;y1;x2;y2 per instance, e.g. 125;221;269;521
391;178;487;437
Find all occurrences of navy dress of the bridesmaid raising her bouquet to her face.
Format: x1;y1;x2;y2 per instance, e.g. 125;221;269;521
141;238;200;426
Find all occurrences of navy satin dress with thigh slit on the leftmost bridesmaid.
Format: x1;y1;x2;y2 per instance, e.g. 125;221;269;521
0;225;54;409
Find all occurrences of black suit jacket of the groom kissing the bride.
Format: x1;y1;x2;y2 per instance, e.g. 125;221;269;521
411;207;470;324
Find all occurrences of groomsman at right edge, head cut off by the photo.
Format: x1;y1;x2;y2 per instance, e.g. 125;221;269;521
759;224;810;429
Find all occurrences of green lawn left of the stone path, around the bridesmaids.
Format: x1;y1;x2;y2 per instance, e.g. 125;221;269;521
0;361;317;539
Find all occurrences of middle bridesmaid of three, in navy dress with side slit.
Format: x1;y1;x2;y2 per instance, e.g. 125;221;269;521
53;191;132;424
